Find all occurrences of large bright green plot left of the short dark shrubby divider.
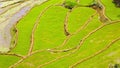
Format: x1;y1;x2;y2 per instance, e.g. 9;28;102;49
34;6;68;50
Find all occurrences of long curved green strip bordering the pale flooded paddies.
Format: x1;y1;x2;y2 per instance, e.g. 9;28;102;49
11;0;63;55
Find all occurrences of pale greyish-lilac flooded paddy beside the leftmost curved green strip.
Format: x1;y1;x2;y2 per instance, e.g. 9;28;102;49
0;0;46;52
